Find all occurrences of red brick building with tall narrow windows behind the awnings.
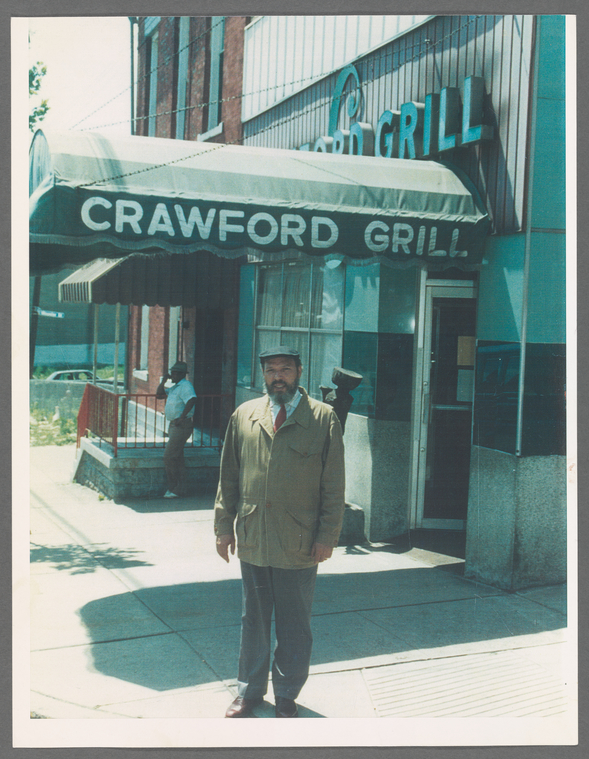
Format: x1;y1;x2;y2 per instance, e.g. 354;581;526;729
127;16;247;395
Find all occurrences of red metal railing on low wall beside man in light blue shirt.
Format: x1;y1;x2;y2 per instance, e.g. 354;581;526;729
77;384;230;456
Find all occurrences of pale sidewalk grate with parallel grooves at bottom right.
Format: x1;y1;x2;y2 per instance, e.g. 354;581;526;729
364;651;569;717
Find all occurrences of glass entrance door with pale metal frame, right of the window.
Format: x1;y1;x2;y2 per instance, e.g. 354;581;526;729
414;280;476;529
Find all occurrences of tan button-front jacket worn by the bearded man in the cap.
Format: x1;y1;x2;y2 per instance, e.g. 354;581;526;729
215;389;345;569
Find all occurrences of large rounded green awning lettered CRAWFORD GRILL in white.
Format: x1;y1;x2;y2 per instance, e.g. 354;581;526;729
29;131;490;274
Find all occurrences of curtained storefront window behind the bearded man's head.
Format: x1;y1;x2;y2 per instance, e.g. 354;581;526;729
249;262;345;399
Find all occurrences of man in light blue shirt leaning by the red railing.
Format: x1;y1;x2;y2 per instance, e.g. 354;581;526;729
155;361;196;498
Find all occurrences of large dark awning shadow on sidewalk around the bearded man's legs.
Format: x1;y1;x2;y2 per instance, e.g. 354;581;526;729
79;567;565;691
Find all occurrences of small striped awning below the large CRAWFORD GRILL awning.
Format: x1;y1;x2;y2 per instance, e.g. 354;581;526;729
59;251;235;310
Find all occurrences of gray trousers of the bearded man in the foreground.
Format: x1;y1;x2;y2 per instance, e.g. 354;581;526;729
237;561;317;699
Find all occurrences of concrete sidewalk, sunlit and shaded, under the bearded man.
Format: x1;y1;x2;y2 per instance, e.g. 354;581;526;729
25;446;574;719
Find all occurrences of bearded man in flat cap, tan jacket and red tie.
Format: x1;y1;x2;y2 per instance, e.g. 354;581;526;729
215;345;344;717
